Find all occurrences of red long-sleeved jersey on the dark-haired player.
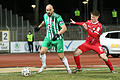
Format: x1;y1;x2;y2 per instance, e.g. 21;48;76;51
75;20;102;45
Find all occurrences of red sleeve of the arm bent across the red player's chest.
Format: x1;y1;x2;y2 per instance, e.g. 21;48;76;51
87;25;102;38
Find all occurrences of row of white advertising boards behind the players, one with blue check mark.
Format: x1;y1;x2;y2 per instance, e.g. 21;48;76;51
11;40;85;53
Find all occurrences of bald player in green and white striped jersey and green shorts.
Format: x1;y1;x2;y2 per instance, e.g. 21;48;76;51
35;4;71;74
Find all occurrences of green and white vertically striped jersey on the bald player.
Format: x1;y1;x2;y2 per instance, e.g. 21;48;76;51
44;13;65;40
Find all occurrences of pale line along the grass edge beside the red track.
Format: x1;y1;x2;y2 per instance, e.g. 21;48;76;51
0;65;119;73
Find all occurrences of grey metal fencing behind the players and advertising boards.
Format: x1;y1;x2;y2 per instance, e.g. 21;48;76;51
0;5;120;41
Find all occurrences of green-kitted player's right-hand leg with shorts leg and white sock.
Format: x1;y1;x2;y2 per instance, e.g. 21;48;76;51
53;40;71;74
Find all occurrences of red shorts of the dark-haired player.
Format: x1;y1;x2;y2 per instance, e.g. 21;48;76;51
78;42;105;54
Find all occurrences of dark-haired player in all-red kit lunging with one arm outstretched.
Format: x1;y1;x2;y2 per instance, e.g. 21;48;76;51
70;11;115;73
